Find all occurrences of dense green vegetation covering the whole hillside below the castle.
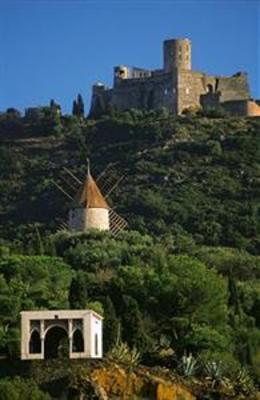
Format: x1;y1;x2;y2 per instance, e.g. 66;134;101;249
0;109;260;399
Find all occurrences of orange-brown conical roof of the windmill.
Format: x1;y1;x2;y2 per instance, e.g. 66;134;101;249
78;173;109;208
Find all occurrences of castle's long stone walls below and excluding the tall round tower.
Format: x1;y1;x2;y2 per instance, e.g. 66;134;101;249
90;69;252;115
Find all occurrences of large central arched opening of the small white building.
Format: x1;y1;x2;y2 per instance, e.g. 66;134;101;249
44;326;69;359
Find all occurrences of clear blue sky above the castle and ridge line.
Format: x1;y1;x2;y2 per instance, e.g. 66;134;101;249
0;0;260;112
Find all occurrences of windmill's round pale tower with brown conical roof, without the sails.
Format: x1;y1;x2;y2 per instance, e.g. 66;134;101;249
69;167;110;231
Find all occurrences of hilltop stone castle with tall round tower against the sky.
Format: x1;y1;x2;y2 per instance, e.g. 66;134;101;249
90;39;260;116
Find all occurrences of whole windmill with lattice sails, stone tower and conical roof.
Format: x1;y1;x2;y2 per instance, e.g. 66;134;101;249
54;160;128;237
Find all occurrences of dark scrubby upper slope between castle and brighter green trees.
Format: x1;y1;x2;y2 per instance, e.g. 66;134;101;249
0;108;260;254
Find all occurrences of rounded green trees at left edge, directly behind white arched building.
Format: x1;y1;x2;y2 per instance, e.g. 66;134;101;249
0;255;72;356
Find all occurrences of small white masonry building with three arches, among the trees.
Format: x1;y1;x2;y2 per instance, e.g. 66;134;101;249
21;310;103;360
